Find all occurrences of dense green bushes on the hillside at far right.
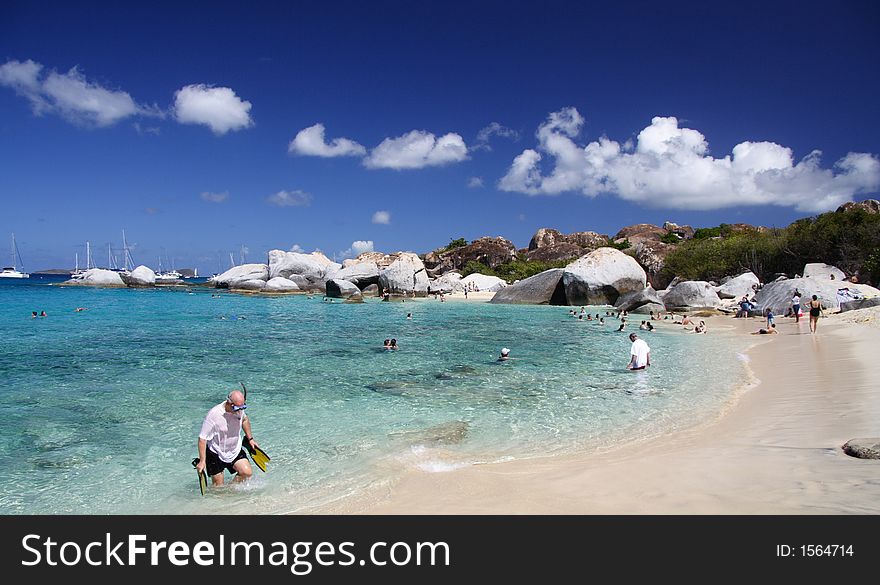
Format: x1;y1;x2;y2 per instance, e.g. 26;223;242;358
663;210;880;283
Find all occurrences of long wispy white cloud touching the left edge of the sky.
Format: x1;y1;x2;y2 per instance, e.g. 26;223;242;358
0;59;156;127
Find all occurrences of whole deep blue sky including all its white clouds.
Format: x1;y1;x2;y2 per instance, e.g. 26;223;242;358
0;2;880;272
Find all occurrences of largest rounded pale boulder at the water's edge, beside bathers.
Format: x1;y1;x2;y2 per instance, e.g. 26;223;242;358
562;248;647;305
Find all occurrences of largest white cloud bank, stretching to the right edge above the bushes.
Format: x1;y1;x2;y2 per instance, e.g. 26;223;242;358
498;108;880;212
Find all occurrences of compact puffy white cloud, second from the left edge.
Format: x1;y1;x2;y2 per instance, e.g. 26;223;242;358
174;83;254;136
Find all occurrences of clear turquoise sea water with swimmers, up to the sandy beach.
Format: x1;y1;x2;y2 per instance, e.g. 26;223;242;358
0;283;745;514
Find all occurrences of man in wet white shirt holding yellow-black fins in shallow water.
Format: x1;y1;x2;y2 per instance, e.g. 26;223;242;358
196;390;259;486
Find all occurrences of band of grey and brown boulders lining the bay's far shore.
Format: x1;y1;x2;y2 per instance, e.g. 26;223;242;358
56;200;880;314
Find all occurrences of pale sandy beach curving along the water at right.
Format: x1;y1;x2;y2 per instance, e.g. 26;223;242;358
322;308;880;514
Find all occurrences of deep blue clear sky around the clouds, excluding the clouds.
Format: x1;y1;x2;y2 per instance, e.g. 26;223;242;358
0;1;880;272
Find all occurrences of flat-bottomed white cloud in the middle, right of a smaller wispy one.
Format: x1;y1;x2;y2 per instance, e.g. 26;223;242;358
364;130;467;170
